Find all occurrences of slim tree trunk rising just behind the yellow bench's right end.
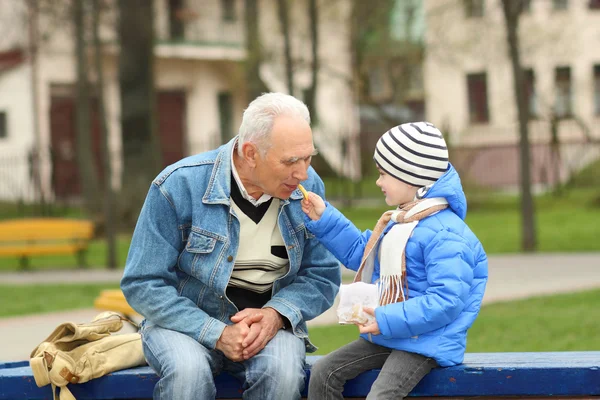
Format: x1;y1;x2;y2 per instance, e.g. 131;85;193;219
73;0;99;218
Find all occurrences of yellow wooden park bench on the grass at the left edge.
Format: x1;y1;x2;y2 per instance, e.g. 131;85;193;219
0;218;94;269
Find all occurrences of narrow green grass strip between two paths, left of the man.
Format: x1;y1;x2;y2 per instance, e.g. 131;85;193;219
0;283;119;317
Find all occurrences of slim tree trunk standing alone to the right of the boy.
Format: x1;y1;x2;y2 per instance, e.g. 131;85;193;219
502;0;537;252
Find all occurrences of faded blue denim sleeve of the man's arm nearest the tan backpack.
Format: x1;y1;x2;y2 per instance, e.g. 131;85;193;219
121;183;226;348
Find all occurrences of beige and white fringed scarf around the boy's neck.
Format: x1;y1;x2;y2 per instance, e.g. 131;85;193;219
354;197;448;306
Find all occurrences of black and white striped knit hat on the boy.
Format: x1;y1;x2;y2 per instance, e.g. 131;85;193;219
373;122;448;187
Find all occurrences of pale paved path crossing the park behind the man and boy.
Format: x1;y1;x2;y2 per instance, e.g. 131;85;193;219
0;253;600;361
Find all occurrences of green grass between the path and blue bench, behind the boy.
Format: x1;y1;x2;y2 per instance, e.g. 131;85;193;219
310;290;600;354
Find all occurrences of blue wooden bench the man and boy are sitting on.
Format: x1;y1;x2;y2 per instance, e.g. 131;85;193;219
0;351;600;400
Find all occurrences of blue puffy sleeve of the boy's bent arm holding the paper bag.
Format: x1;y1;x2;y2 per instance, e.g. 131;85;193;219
375;230;475;338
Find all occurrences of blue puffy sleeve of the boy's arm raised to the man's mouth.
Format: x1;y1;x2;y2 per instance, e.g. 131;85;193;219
304;202;371;271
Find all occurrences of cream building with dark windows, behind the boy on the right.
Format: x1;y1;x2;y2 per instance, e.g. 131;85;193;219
423;0;600;185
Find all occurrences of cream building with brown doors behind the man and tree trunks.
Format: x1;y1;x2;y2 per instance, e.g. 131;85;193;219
0;0;360;201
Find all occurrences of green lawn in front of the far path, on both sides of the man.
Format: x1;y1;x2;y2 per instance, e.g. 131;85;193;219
0;284;600;354
